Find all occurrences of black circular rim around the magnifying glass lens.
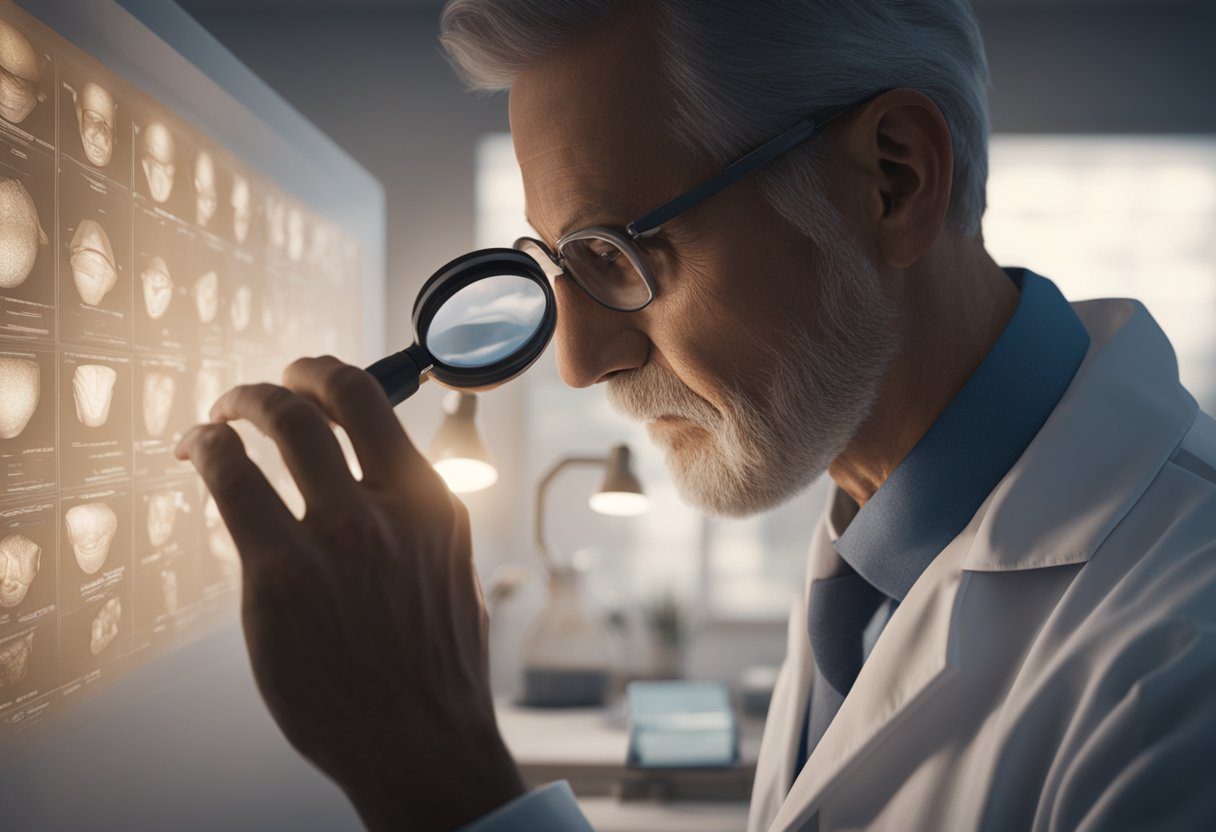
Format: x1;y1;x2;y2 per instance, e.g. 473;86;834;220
413;248;557;387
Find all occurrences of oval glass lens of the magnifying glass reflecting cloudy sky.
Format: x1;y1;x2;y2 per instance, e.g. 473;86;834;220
426;275;547;369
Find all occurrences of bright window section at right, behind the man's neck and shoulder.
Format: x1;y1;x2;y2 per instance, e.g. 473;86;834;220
984;136;1216;411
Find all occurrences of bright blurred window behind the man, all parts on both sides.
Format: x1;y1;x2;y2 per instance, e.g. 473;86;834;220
477;134;1216;620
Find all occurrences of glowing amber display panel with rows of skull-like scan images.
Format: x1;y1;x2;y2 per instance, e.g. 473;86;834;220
0;0;362;733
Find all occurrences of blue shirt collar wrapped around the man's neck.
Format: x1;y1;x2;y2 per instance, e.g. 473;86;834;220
835;269;1090;601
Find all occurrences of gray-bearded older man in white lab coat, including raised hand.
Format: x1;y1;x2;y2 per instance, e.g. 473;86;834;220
179;0;1216;832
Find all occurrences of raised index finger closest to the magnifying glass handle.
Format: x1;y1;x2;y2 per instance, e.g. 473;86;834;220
283;355;430;485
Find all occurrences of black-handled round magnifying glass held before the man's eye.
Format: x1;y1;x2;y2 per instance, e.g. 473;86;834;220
367;248;557;405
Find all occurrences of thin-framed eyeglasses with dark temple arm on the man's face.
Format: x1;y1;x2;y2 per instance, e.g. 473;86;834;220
514;92;880;313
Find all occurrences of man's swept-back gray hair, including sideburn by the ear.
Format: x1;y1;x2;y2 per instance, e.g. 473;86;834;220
441;0;989;238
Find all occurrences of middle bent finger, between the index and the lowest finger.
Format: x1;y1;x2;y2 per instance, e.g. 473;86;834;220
212;384;358;512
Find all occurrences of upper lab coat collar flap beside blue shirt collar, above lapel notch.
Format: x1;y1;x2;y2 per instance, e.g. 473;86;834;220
963;299;1198;572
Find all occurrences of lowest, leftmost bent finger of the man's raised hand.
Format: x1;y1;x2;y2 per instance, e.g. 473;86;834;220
174;425;297;563
